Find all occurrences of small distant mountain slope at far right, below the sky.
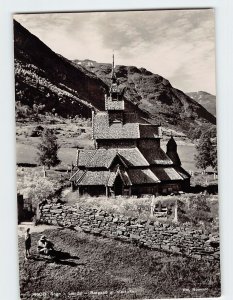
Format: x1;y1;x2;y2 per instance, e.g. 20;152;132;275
187;91;216;116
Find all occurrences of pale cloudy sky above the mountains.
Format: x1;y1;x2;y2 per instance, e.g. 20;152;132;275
14;9;215;94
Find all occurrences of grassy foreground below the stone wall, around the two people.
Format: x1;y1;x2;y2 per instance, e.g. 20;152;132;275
19;228;220;300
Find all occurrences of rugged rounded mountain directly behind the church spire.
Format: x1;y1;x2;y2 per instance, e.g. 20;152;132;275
74;60;216;130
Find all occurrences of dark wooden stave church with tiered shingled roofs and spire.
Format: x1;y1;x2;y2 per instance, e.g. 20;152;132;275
70;56;191;197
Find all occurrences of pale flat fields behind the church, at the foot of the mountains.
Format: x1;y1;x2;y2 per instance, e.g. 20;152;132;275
16;120;196;171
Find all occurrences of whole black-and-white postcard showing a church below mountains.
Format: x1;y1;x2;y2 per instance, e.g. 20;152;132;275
13;9;221;300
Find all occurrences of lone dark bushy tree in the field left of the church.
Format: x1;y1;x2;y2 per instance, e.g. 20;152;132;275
37;129;60;169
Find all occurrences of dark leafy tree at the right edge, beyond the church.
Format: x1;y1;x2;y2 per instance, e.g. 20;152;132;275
195;126;217;170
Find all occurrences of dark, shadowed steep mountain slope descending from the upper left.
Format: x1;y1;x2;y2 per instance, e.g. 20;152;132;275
14;21;144;117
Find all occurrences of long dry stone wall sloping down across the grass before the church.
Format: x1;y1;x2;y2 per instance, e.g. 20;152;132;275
38;204;220;260
